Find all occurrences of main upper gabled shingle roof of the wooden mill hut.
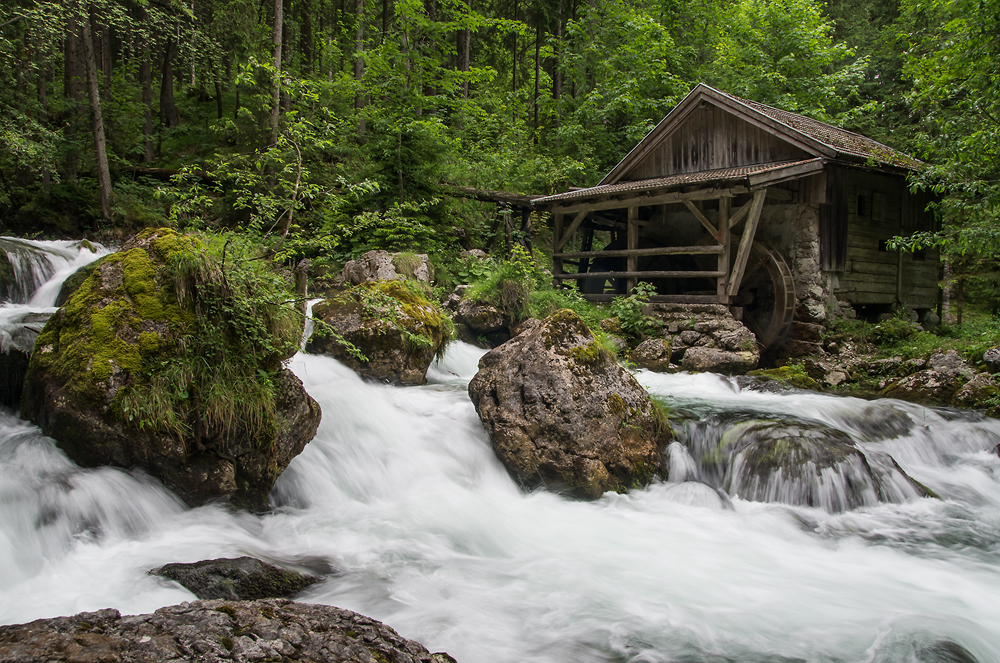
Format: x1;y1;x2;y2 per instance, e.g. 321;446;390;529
599;83;923;185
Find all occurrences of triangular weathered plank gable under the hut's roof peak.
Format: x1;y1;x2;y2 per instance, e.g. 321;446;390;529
622;104;810;181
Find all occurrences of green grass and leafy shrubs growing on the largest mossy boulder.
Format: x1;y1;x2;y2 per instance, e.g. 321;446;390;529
112;235;302;445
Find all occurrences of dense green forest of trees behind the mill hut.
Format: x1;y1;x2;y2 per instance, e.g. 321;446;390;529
0;0;1000;304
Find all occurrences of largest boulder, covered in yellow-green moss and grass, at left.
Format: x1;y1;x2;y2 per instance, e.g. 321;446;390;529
21;229;320;510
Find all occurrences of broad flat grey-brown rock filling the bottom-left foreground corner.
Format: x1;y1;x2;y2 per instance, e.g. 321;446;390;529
0;599;454;663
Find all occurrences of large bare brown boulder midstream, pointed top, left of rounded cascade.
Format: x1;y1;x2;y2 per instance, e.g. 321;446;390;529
469;309;669;499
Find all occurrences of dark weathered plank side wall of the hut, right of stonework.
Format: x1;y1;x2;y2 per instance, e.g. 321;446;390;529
836;168;938;308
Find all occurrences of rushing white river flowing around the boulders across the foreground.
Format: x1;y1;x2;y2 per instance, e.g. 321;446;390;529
0;241;1000;663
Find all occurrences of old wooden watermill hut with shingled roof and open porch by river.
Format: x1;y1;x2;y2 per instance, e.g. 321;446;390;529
534;84;938;346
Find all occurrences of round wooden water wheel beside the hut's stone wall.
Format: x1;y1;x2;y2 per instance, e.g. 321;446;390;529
733;242;795;349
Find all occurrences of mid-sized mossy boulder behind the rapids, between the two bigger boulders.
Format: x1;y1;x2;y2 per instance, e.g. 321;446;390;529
306;281;447;384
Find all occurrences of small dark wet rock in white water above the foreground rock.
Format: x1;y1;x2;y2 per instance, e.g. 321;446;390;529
149;557;320;601
